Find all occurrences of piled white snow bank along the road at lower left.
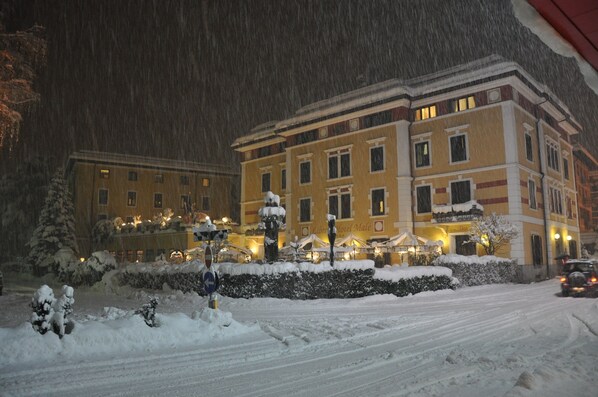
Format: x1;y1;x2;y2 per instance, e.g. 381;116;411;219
0;307;262;372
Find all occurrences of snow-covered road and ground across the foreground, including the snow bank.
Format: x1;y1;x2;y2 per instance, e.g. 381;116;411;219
0;275;598;397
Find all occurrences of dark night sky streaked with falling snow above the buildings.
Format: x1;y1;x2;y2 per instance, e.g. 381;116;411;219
12;0;598;167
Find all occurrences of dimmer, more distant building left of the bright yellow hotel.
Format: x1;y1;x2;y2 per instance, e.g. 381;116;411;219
65;151;239;262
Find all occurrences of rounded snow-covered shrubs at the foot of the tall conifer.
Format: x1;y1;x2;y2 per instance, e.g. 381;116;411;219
55;251;116;286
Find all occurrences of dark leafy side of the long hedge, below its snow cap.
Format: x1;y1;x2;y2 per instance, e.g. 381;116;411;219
118;269;453;300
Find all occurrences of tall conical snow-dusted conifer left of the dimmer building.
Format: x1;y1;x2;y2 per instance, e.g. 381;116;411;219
27;168;78;274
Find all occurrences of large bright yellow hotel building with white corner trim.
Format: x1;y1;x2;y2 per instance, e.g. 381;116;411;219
232;56;581;280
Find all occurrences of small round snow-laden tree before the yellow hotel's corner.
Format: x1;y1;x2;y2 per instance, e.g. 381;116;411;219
466;212;519;255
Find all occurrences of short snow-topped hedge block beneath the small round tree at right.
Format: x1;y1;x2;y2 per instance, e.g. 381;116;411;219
434;254;517;286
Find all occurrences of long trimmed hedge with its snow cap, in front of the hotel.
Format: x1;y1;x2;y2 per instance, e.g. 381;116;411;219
118;260;454;299
